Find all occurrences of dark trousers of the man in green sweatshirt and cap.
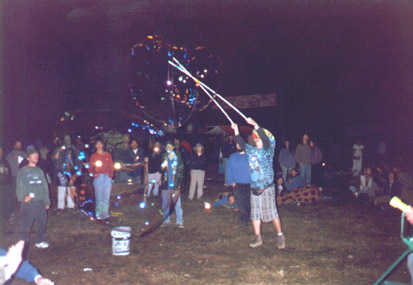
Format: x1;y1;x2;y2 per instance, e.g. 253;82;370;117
20;201;47;243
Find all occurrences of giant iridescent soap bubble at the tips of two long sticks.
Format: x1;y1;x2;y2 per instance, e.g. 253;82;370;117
128;35;222;128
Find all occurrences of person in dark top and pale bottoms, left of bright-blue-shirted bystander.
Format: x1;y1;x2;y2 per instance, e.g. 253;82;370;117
148;142;162;197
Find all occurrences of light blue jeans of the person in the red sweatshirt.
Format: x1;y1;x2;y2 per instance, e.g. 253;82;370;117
93;174;112;219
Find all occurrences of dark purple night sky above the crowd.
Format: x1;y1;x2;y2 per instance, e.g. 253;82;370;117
1;0;413;149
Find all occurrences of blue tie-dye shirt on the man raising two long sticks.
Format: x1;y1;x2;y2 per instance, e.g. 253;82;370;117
236;128;275;189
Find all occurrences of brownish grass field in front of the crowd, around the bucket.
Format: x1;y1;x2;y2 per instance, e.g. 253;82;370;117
3;173;409;284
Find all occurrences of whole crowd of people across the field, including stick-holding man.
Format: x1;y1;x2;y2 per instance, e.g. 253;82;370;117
0;118;413;282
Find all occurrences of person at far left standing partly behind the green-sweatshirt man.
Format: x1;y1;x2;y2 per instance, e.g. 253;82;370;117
6;141;26;217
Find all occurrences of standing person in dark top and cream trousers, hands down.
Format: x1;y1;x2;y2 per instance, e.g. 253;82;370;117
188;143;208;200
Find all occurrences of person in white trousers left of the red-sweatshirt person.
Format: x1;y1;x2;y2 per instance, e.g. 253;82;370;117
52;135;82;210
